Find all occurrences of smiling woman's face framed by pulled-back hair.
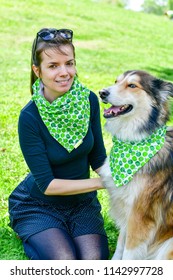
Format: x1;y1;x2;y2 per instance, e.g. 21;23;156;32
33;46;76;102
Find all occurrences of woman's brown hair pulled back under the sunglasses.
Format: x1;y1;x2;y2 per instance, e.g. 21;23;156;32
30;28;75;94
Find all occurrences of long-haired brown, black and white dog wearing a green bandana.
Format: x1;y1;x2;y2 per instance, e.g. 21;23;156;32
99;70;173;260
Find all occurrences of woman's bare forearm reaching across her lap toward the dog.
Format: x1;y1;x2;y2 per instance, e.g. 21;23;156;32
44;178;103;195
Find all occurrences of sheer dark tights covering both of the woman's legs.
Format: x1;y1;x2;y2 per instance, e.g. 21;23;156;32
23;228;109;260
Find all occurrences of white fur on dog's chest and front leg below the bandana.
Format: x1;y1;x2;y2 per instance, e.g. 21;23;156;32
100;158;153;259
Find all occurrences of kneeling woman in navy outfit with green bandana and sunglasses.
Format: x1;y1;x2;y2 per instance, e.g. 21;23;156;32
9;28;108;260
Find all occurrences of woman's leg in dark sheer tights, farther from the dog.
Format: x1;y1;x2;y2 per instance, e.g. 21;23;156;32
24;228;76;260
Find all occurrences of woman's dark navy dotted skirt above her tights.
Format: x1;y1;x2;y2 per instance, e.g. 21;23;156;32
9;180;106;241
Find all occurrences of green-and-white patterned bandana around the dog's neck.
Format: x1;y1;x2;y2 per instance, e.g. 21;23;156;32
109;126;166;187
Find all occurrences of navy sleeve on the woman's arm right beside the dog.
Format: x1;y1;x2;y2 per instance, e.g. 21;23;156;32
89;92;106;170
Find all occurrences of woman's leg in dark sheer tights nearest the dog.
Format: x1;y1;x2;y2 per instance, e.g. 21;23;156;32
74;234;109;260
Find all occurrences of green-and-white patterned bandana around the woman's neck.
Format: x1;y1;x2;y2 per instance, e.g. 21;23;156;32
32;77;90;153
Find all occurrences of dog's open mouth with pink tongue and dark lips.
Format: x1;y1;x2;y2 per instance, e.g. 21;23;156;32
103;104;133;118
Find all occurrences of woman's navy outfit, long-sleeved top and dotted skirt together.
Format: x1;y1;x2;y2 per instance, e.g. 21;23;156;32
9;92;106;241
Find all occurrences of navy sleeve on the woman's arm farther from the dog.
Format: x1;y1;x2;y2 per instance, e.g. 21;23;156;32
18;109;54;193
